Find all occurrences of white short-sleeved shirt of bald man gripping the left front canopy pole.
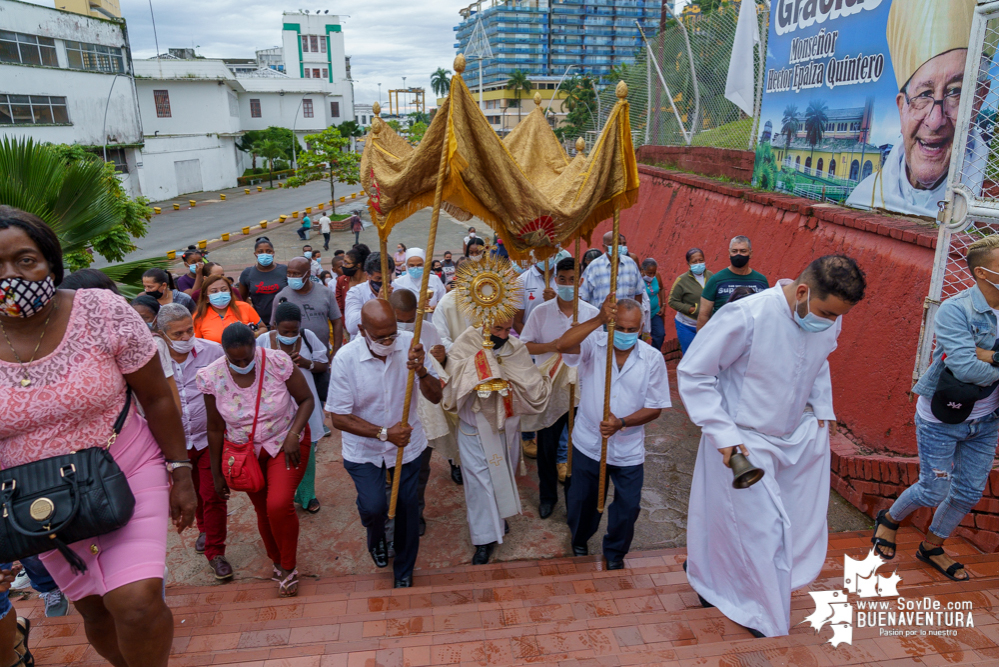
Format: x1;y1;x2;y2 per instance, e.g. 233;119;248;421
326;331;437;468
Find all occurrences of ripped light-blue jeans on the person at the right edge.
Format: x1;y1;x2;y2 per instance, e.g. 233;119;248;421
888;413;999;538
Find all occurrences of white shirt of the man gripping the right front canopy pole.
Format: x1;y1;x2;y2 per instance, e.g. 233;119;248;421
562;331;672;466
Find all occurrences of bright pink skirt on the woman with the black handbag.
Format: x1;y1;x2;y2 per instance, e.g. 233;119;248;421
41;411;170;602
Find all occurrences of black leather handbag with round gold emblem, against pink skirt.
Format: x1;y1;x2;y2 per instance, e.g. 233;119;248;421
0;389;135;574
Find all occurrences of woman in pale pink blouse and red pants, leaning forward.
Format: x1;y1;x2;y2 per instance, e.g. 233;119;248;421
197;322;315;597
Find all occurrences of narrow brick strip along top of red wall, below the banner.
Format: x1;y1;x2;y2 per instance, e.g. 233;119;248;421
638;164;937;248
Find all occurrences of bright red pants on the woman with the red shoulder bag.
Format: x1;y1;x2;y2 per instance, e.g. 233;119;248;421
246;438;311;570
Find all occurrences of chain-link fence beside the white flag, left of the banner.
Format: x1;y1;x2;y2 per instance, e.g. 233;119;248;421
566;0;770;154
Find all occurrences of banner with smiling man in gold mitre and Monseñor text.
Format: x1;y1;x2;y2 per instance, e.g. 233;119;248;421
744;0;981;217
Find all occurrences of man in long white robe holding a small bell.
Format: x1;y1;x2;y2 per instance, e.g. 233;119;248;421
677;255;866;637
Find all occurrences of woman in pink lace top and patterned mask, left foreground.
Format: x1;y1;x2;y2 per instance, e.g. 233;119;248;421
0;206;196;667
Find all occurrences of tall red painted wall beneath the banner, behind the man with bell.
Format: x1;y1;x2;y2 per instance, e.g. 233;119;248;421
593;165;936;455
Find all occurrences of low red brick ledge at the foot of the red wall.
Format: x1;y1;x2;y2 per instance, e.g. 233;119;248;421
830;433;999;553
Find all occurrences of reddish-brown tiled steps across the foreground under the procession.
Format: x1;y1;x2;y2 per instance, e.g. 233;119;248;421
18;528;999;667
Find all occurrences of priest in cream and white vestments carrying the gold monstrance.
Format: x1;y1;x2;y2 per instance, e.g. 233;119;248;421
441;318;552;565
